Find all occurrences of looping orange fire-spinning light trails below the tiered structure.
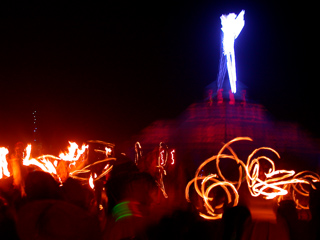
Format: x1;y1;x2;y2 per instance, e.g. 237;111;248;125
185;137;320;219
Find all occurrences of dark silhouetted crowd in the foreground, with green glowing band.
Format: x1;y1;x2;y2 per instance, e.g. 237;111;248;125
0;149;320;240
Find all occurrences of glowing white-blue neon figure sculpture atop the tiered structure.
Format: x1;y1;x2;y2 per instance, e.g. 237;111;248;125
218;10;244;93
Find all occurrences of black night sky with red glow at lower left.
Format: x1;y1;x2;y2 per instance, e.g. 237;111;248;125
0;0;320;150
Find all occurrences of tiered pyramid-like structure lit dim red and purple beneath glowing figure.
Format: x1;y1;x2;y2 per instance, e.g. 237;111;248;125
132;85;320;171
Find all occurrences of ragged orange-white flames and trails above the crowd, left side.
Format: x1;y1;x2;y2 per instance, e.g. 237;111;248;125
0;141;116;188
